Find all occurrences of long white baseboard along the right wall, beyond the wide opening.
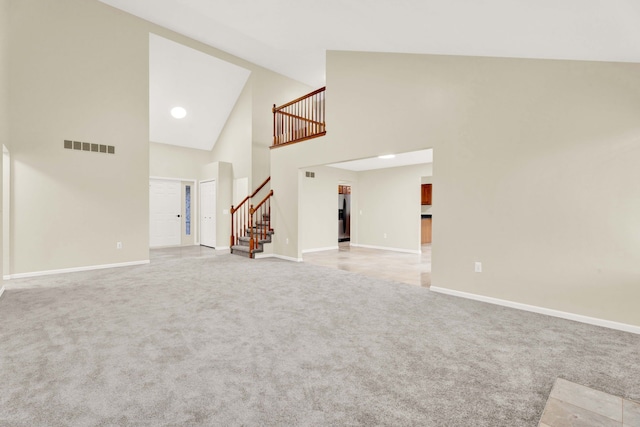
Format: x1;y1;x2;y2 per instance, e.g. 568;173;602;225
429;286;640;334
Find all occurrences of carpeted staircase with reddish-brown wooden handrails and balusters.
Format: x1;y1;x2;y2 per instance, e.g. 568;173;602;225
230;177;273;258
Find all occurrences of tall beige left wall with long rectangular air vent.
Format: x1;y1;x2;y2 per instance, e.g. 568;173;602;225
8;0;149;274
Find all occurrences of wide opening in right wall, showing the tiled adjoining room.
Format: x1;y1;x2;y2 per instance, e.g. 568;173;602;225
300;148;433;287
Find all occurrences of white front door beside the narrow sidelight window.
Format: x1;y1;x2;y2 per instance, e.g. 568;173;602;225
149;179;182;248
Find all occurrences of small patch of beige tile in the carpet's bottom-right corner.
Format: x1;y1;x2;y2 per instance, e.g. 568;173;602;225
539;378;640;427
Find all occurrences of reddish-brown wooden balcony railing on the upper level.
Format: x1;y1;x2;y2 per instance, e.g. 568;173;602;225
271;87;327;148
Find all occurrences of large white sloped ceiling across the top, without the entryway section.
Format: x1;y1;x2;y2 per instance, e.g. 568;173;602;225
101;0;640;87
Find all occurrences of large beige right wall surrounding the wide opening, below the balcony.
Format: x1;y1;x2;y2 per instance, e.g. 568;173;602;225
272;52;640;325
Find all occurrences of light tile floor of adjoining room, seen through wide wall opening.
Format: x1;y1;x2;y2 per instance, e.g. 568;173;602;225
302;242;431;288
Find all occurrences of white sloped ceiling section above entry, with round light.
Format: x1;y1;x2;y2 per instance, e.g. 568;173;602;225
149;34;250;150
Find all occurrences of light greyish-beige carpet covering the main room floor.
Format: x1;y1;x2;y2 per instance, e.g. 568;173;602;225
0;255;640;426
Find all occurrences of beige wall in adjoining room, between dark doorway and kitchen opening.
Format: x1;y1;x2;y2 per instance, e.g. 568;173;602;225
360;164;431;252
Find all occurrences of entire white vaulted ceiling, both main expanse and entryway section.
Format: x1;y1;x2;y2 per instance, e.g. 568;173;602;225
100;0;640;150
